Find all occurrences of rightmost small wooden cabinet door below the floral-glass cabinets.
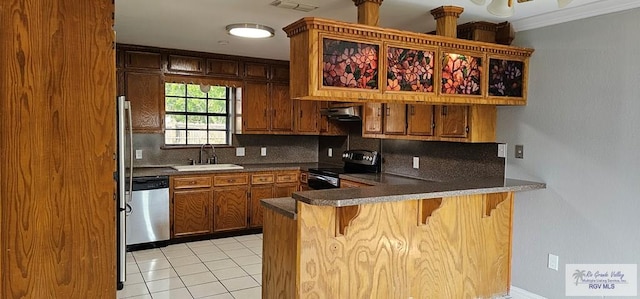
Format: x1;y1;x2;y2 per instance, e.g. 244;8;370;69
436;105;469;138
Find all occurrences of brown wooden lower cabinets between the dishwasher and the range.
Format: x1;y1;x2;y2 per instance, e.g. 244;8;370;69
170;171;300;238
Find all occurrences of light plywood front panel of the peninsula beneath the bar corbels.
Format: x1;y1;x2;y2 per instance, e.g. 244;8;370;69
296;193;513;299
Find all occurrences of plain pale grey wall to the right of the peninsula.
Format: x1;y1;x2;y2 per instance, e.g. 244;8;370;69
498;9;640;298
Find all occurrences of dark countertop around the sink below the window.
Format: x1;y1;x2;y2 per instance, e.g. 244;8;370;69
133;162;340;177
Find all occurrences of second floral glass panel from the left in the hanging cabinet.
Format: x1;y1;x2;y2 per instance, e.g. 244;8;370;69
387;47;435;92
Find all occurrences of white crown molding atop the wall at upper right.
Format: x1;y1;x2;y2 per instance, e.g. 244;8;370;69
511;0;640;31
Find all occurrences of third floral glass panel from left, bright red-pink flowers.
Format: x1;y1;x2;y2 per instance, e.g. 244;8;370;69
442;53;482;95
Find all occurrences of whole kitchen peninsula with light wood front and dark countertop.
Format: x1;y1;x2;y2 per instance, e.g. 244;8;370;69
262;174;546;298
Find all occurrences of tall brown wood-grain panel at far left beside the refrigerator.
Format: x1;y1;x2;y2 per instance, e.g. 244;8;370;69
0;0;116;299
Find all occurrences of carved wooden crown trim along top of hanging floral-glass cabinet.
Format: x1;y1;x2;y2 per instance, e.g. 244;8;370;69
283;17;533;57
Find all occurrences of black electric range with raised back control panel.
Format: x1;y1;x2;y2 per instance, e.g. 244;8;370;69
308;150;381;190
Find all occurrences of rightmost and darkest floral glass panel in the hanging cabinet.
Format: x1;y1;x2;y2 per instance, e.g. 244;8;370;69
489;58;524;97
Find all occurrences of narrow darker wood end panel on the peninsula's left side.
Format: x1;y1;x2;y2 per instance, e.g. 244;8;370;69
262;209;298;299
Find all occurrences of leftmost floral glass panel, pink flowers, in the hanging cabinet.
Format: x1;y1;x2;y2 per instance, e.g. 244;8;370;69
322;38;379;89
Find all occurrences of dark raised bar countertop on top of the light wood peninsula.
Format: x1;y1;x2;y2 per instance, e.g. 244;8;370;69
293;179;546;207
